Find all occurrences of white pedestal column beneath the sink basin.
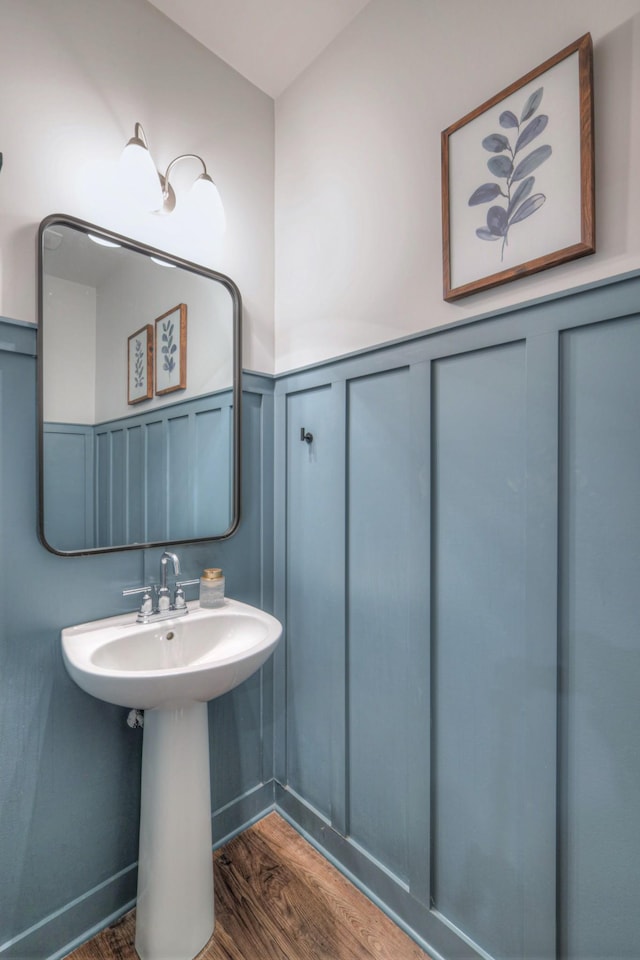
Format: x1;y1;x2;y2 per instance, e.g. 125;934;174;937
135;703;214;960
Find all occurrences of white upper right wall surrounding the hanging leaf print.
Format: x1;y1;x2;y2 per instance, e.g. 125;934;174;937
275;0;640;371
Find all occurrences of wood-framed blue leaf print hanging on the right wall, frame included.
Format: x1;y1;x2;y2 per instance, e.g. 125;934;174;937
441;33;595;301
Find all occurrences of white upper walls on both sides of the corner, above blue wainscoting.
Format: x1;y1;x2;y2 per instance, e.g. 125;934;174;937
0;0;640;372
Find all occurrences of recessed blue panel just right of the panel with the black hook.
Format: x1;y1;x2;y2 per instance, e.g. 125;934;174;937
347;369;412;881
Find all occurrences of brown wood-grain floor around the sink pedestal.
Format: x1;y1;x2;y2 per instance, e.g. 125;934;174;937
67;813;429;960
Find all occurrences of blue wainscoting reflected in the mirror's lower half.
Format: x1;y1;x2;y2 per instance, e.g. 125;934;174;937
44;390;233;551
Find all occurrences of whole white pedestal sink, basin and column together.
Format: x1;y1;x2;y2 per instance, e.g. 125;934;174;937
62;600;282;960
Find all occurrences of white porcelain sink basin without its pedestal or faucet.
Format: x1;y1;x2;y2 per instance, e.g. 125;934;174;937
62;600;282;709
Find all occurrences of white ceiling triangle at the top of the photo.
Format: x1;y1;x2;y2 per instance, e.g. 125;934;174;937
146;0;369;98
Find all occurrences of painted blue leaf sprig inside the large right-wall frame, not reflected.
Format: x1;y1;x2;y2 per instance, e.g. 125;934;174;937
468;87;552;260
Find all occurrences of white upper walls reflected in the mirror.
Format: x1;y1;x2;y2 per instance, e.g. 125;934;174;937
43;251;233;424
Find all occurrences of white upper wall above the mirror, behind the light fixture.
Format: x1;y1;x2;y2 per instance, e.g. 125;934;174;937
0;0;274;371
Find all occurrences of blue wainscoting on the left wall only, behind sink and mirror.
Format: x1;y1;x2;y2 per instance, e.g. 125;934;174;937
0;332;274;960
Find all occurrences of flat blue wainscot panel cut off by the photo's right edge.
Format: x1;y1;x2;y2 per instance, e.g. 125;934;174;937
560;316;640;960
